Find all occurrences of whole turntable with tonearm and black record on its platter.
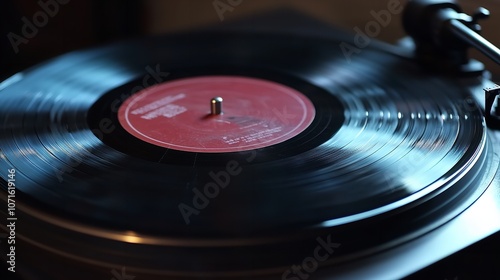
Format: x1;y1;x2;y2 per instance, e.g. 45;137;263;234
0;1;500;279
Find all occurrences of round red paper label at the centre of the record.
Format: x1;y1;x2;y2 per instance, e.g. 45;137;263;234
118;76;315;153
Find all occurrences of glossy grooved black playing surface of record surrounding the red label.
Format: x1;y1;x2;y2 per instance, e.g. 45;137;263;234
0;30;484;234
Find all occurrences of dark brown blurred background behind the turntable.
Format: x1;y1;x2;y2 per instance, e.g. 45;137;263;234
0;0;500;79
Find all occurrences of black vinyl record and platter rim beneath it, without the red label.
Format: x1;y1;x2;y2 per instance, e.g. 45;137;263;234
0;29;488;275
